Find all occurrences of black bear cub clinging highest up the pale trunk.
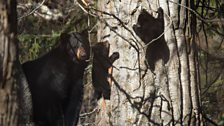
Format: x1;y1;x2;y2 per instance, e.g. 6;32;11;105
133;8;170;71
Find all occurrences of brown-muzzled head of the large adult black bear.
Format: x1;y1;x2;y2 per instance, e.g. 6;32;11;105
60;31;90;62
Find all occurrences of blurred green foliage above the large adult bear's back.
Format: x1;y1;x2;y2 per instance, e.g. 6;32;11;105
18;3;96;63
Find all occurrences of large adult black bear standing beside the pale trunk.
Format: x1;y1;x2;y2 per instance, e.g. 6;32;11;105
23;32;90;126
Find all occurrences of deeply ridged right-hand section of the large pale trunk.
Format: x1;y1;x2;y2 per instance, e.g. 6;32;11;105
160;0;203;125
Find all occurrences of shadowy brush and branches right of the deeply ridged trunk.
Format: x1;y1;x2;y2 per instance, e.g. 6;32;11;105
197;0;224;122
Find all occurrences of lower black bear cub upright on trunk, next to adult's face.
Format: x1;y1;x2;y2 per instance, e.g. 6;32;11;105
92;41;119;99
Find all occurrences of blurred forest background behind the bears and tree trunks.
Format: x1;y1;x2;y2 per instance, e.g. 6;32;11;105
0;0;224;125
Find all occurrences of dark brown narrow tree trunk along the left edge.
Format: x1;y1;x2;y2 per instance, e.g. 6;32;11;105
0;0;18;126
